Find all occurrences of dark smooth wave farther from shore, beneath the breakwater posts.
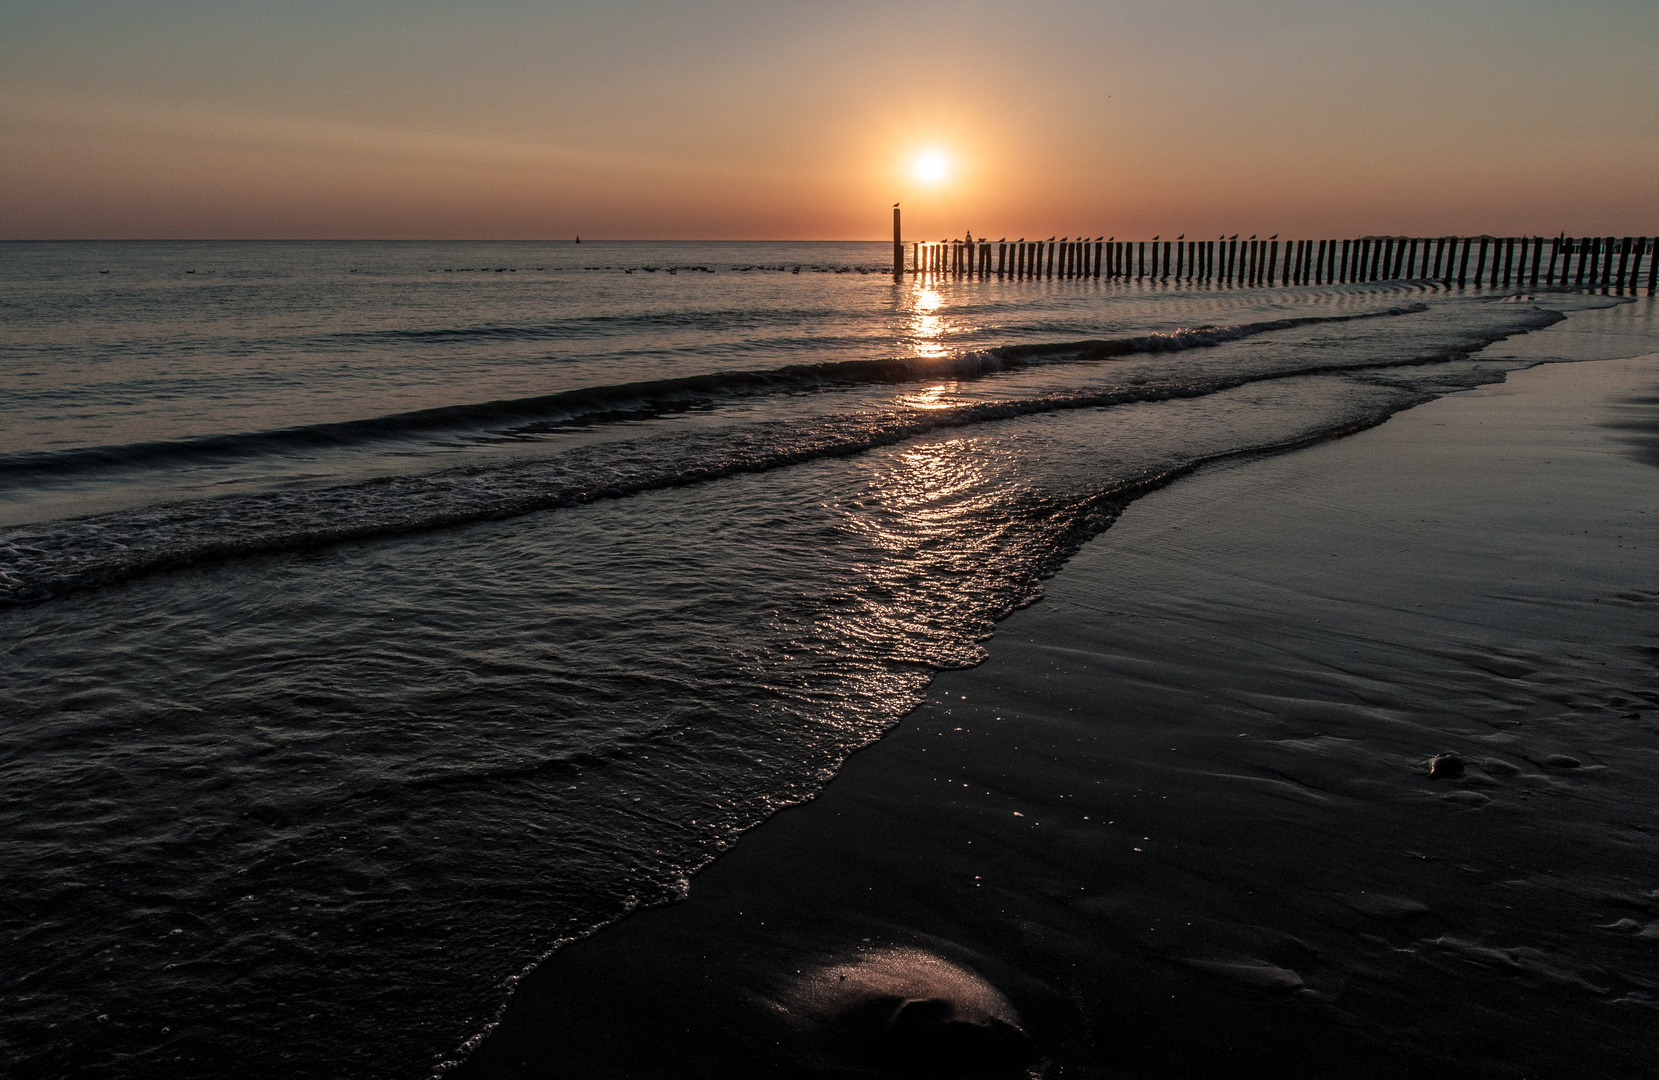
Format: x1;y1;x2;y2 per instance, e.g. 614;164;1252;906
0;304;1428;484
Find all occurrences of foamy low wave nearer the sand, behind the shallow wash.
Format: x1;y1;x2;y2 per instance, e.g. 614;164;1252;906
0;301;1561;606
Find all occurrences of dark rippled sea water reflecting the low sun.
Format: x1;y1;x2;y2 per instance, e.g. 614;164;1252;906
0;242;1606;1077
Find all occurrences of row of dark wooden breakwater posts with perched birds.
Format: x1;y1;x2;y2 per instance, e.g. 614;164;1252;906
893;222;1659;295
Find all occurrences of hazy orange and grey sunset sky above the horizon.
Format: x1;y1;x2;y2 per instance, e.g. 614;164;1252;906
0;0;1659;239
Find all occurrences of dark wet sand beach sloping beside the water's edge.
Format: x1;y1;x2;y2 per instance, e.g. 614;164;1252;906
460;326;1659;1078
